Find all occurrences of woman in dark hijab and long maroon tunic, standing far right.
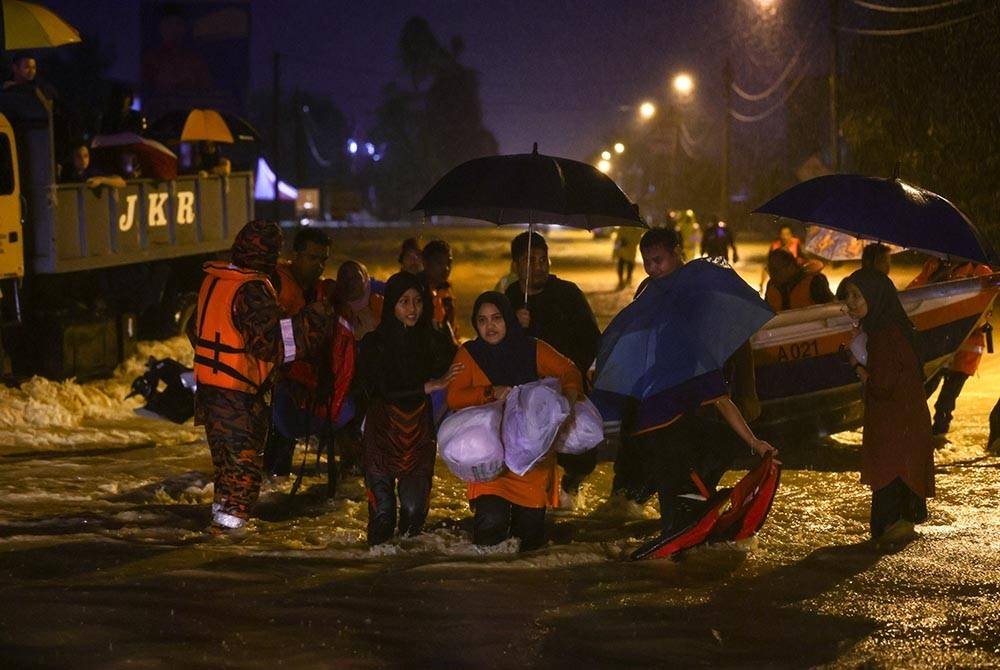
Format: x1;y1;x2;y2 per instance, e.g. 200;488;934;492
844;268;934;544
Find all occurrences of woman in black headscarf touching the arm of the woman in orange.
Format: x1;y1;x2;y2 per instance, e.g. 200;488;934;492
355;272;461;546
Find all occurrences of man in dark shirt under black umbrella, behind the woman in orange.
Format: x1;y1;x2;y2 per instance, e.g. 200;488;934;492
506;232;601;496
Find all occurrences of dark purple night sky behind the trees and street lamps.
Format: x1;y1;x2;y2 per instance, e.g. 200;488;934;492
35;0;769;159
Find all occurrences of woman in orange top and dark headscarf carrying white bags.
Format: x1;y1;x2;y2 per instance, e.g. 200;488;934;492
448;291;583;551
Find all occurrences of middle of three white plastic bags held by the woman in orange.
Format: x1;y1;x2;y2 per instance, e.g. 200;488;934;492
501;377;569;475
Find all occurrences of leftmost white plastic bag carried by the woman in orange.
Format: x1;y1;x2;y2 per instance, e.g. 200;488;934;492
438;400;504;482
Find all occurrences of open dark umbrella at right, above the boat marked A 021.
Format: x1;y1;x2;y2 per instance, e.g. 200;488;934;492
754;174;998;264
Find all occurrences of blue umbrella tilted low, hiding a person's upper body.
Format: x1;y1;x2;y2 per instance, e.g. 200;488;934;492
593;260;774;430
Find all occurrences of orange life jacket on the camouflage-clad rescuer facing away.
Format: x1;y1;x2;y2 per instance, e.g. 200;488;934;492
194;263;274;393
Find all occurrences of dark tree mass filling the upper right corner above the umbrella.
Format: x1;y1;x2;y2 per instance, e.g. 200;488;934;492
841;5;1000;252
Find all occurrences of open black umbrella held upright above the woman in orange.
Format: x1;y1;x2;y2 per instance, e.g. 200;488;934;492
413;144;646;230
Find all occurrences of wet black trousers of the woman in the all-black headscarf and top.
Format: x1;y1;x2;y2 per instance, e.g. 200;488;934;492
365;474;432;546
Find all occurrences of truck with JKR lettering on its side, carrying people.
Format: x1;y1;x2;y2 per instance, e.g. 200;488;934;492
0;94;254;380
